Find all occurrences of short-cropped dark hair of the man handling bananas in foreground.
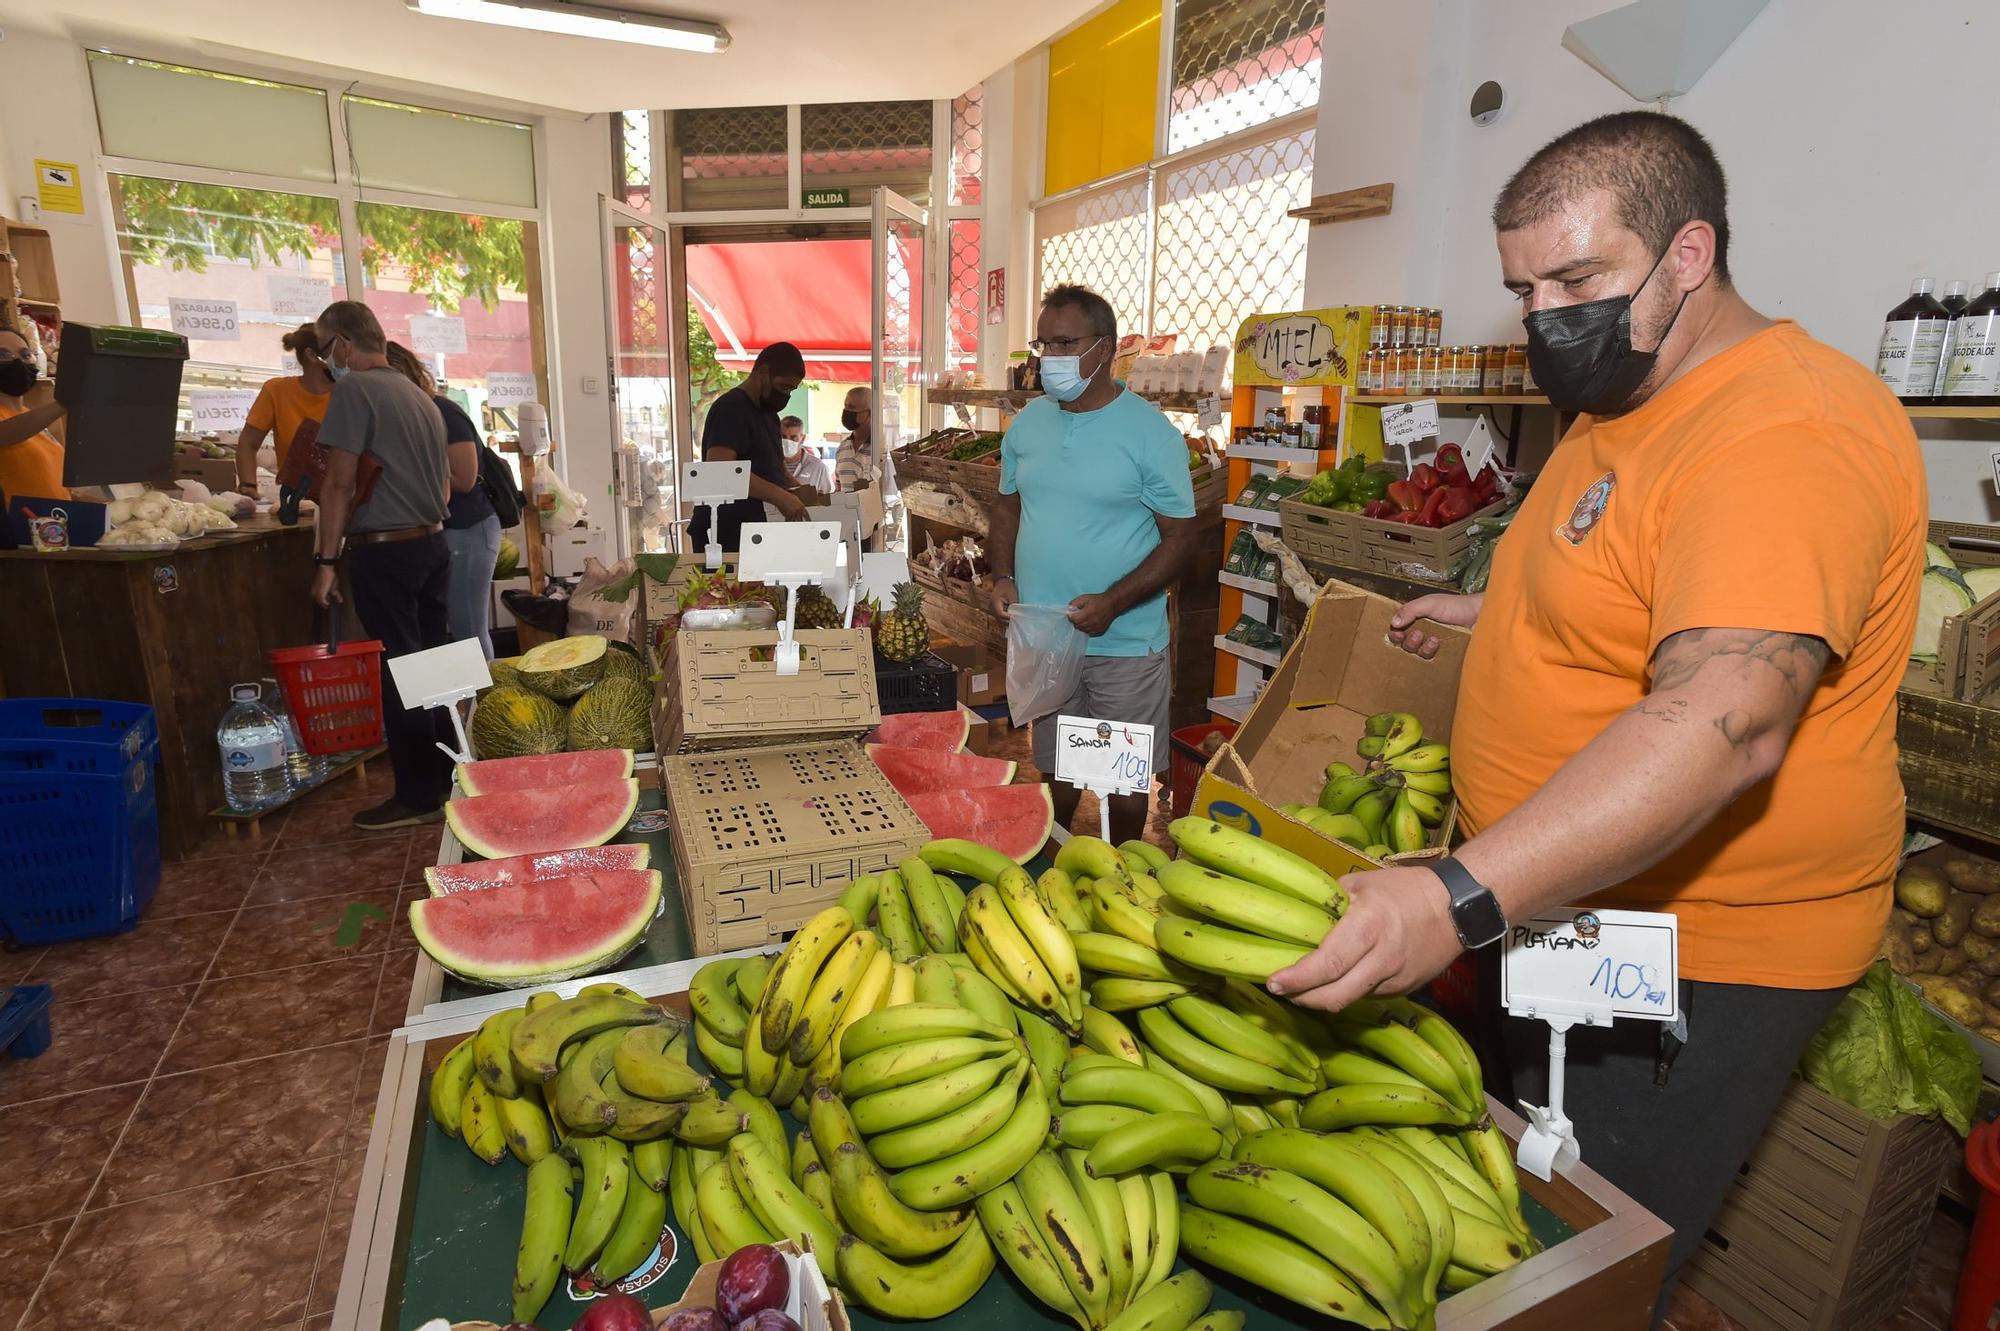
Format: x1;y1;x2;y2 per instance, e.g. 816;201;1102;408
1494;112;1730;288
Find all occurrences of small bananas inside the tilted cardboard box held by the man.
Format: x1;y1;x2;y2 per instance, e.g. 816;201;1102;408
1280;711;1452;859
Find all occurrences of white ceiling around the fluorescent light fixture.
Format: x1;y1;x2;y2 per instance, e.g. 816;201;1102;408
0;0;1102;112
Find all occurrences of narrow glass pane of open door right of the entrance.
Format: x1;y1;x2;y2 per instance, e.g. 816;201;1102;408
872;188;930;550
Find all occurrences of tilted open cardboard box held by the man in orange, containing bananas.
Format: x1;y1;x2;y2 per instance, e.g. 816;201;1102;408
1192;582;1472;873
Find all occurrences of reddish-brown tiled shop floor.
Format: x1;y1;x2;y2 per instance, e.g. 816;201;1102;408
0;751;1966;1331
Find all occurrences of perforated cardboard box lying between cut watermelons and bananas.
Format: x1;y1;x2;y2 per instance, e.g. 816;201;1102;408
660;739;930;955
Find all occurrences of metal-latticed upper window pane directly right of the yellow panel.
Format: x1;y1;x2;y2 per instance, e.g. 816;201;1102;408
1166;0;1326;154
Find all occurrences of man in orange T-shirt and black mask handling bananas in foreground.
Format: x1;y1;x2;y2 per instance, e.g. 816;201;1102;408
1270;112;1928;1319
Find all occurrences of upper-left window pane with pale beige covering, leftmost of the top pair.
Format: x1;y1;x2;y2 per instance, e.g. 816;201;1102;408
86;50;334;184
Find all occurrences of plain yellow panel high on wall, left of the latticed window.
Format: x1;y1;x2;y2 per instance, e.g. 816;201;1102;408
1042;0;1160;194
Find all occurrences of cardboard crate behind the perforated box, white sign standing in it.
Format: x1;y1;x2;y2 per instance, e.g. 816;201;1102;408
652;630;882;753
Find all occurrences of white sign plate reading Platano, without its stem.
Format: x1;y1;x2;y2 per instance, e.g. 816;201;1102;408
1500;909;1680;1023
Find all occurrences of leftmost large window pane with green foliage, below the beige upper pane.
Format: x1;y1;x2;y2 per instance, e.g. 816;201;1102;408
108;176;348;419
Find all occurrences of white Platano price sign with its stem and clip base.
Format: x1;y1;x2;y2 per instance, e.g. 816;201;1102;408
1500;909;1680;1179
